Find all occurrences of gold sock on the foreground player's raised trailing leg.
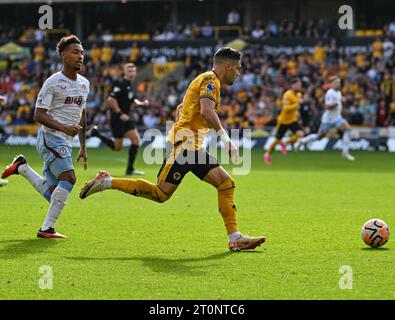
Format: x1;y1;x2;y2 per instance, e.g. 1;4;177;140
111;178;170;202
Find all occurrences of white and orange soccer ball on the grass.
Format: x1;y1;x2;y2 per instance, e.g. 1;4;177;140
362;219;390;248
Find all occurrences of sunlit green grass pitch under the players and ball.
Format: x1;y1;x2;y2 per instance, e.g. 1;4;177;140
0;146;395;300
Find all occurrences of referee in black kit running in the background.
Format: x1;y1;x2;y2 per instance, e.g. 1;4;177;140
87;63;149;175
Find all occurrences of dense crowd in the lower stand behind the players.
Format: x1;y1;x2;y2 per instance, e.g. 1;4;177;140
0;38;395;135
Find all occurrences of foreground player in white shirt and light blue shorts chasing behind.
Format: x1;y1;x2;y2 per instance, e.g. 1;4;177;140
1;35;89;238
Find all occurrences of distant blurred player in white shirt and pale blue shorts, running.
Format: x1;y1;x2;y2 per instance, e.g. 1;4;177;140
297;76;355;161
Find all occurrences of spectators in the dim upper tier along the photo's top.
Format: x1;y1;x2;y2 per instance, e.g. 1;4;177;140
0;17;395;43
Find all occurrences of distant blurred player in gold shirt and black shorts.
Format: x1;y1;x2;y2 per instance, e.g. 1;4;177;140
263;79;304;165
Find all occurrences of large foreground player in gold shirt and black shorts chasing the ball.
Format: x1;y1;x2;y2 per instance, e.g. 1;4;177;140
80;47;266;251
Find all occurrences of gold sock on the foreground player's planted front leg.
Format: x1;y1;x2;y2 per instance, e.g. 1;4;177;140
217;178;239;234
